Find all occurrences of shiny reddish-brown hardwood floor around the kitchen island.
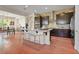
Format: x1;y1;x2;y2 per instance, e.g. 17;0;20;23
0;32;78;54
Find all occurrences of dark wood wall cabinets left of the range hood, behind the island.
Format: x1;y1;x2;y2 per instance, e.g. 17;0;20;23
34;16;49;29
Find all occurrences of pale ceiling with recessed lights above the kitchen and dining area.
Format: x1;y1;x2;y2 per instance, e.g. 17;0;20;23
0;5;74;16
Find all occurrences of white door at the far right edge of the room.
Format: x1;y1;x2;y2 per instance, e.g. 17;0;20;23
75;5;79;51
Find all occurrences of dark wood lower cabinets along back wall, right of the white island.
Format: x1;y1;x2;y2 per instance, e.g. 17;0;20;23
50;29;71;37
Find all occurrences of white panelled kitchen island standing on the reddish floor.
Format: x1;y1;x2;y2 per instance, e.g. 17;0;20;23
24;29;50;45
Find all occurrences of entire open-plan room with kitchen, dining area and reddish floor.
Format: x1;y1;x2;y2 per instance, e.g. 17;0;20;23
0;5;79;54
